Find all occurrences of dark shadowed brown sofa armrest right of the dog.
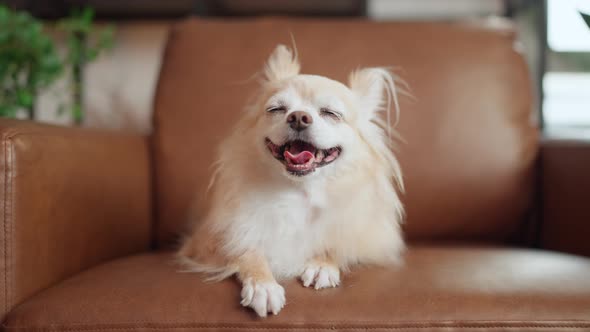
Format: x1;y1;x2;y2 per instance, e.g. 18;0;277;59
540;138;590;256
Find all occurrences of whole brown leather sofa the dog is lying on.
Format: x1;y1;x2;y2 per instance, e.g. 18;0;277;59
0;18;590;331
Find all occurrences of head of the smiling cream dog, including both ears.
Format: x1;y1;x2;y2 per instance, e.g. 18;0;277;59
243;45;399;180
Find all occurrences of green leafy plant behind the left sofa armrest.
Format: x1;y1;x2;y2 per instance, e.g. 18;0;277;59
0;5;114;125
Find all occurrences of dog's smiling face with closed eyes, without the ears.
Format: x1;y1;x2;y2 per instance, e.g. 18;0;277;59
260;75;357;177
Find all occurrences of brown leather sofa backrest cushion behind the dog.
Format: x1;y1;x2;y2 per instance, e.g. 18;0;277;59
154;18;538;244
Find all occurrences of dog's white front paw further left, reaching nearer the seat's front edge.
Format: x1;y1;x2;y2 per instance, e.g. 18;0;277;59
240;278;285;317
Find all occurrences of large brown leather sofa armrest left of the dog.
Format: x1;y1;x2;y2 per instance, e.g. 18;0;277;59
0;119;152;321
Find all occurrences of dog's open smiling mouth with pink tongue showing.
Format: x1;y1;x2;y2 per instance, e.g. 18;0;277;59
266;138;342;176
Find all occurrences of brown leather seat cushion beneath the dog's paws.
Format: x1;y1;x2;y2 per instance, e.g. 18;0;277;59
4;246;590;332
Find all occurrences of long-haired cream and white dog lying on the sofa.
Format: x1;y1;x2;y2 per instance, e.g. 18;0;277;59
178;45;405;317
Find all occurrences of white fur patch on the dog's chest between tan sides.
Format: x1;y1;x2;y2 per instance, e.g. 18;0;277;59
222;179;333;277
